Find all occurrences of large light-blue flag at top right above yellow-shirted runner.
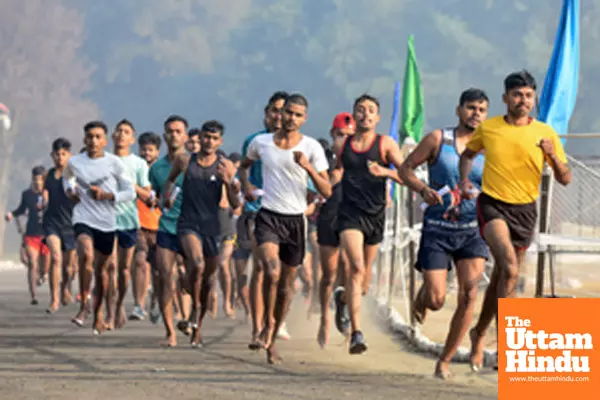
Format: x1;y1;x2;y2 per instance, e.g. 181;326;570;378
538;0;579;145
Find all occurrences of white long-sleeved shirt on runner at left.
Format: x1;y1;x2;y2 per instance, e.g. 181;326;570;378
63;152;135;232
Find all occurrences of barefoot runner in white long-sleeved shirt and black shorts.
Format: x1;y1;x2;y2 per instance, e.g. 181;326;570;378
63;121;135;335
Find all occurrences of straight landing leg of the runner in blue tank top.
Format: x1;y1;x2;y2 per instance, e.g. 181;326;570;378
435;258;485;379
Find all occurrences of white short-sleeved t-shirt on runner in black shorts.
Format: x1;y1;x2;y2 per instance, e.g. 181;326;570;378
246;134;329;215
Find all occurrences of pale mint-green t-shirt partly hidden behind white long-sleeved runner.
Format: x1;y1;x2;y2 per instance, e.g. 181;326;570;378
117;154;150;231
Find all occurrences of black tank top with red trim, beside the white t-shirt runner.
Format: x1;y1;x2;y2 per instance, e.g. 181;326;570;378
340;134;388;215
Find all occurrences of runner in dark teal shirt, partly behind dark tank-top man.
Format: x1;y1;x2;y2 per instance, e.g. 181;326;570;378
149;115;188;347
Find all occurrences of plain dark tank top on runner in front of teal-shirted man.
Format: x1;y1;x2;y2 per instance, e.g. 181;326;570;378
179;154;223;236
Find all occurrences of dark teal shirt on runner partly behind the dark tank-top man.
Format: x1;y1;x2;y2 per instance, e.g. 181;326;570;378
149;156;183;235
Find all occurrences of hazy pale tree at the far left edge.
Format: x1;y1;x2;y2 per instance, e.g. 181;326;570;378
0;0;98;254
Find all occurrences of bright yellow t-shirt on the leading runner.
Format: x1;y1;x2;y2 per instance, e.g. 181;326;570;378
467;116;567;204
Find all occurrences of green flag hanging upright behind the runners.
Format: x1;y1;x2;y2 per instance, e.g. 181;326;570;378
400;35;425;143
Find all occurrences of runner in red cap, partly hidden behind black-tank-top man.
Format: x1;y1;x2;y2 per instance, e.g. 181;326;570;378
317;113;356;347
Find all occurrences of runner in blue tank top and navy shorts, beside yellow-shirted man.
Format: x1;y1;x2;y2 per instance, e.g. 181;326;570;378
399;89;489;379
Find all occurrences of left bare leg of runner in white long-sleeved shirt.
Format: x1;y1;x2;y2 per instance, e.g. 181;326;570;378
71;232;94;327
